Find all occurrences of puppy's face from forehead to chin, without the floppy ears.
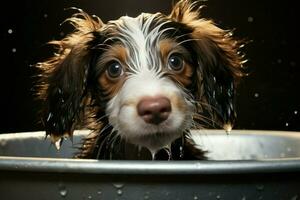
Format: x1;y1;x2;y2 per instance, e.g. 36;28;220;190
95;14;197;150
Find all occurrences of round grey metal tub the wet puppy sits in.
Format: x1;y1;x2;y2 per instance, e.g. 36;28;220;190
0;130;300;200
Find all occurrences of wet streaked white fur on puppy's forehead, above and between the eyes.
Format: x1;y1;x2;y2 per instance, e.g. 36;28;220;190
102;13;189;72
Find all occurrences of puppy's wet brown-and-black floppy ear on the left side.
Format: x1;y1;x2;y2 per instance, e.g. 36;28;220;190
37;10;102;142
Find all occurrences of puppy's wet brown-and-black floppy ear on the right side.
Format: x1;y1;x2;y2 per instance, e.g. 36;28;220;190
170;0;245;130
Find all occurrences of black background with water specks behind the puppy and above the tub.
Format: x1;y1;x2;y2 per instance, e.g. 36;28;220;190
0;0;300;133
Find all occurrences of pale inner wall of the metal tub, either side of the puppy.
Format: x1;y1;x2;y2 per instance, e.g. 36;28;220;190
0;130;300;160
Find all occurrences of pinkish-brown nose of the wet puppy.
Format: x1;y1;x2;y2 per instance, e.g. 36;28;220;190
137;96;172;125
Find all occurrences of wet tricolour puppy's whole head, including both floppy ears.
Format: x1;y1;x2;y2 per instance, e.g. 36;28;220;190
38;0;242;151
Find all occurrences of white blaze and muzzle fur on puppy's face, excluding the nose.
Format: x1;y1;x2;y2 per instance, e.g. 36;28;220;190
106;14;193;152
